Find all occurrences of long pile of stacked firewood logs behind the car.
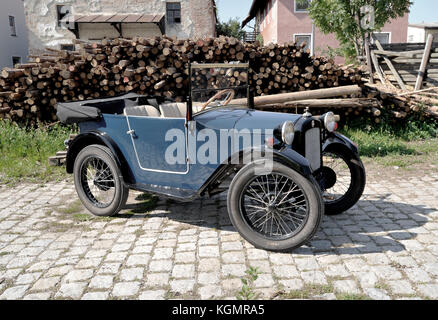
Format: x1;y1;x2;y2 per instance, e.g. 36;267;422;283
0;36;362;124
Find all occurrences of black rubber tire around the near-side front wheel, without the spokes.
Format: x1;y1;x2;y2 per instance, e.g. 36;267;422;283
227;161;324;252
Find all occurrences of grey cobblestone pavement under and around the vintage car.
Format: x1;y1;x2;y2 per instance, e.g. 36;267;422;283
0;165;438;299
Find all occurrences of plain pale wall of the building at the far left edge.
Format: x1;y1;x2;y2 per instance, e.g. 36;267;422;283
0;0;28;68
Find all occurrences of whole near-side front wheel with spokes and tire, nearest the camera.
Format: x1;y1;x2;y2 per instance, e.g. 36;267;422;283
227;162;324;251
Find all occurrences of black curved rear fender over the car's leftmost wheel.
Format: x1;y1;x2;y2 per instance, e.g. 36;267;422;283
66;130;135;184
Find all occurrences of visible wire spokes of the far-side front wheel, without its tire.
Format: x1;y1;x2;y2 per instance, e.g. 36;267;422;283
323;152;353;203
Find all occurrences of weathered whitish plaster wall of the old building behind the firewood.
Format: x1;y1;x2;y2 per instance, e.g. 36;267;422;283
24;0;216;52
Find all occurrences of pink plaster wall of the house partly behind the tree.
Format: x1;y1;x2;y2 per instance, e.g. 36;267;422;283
262;0;409;63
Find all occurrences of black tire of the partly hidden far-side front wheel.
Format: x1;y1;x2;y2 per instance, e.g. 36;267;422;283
323;148;366;216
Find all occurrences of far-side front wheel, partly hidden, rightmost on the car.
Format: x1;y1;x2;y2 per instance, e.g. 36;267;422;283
319;149;366;215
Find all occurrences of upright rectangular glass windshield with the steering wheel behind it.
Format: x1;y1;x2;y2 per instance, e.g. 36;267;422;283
190;63;248;114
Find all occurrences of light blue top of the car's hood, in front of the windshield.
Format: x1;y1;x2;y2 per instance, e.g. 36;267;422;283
195;107;301;130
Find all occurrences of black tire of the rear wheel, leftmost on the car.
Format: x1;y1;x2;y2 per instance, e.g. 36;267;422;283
73;145;129;216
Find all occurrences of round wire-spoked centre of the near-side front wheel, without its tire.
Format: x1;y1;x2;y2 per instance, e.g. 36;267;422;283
240;173;309;240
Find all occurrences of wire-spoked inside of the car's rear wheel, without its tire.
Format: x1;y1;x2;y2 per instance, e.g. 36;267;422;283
80;156;116;208
